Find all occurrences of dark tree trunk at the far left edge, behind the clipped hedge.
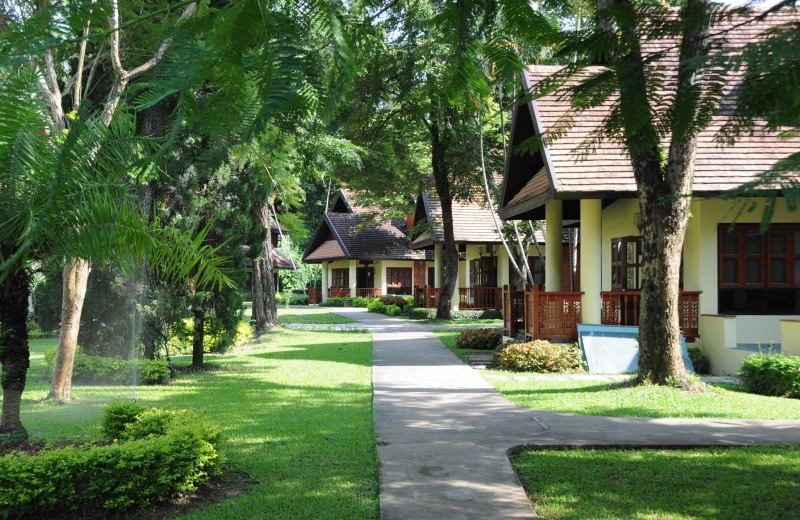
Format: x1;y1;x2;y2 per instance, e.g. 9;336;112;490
0;246;30;438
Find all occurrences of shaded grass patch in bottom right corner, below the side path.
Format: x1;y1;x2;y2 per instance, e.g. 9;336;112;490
512;446;800;520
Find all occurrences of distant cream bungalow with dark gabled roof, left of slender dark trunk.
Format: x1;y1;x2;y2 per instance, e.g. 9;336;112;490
303;190;433;301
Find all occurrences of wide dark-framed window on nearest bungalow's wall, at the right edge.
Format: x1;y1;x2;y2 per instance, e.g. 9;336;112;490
718;224;800;314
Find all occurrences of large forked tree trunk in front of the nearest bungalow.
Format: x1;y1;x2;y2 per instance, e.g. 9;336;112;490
598;0;709;387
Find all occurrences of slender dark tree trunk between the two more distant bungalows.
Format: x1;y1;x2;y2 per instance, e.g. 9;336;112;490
430;122;458;320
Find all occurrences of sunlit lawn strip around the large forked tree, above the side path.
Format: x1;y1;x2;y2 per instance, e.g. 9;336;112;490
435;330;800;419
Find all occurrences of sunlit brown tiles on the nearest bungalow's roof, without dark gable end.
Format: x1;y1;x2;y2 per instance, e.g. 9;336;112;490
506;10;800;207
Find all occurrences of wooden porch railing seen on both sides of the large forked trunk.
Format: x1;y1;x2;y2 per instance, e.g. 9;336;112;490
600;291;700;341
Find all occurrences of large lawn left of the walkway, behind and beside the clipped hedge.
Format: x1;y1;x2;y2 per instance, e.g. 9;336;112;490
9;329;379;519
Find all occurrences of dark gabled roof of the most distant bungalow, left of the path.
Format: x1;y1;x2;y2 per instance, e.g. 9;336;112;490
303;213;432;263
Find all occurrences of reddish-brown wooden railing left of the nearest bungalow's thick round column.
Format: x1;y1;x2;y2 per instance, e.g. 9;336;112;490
525;285;583;341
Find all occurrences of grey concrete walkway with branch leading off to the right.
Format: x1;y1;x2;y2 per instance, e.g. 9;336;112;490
335;309;800;520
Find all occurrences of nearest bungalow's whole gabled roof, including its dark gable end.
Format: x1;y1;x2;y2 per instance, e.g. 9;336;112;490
500;10;798;218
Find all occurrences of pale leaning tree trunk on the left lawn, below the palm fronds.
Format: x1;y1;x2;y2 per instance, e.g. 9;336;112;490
47;258;89;402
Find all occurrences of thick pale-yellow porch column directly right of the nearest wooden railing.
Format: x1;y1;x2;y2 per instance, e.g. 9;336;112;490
580;199;603;325
